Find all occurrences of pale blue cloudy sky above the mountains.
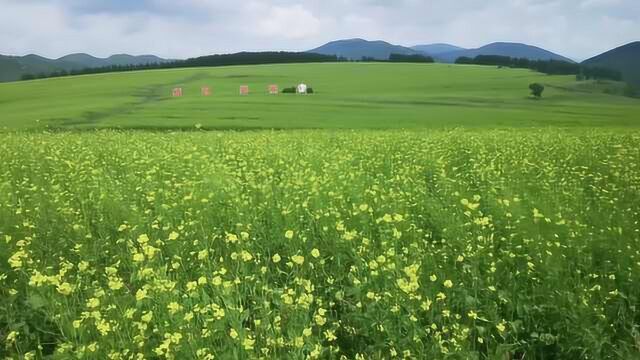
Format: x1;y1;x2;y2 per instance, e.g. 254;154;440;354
0;0;640;60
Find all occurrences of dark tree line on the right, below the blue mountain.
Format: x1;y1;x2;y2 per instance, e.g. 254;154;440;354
456;55;622;81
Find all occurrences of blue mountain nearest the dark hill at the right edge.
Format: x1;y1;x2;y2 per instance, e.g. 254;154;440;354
438;42;573;62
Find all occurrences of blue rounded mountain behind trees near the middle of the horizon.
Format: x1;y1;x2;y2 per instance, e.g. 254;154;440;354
307;39;422;60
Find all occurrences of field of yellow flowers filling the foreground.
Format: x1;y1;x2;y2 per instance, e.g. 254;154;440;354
0;130;640;359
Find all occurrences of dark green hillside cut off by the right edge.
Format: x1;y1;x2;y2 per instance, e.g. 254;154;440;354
582;41;640;87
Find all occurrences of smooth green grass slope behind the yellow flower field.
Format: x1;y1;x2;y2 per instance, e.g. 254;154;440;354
0;63;640;130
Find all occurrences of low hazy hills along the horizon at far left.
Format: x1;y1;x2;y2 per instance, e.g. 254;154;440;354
0;54;171;82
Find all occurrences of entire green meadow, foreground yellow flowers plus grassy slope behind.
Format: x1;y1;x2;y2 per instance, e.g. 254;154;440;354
0;64;640;360
